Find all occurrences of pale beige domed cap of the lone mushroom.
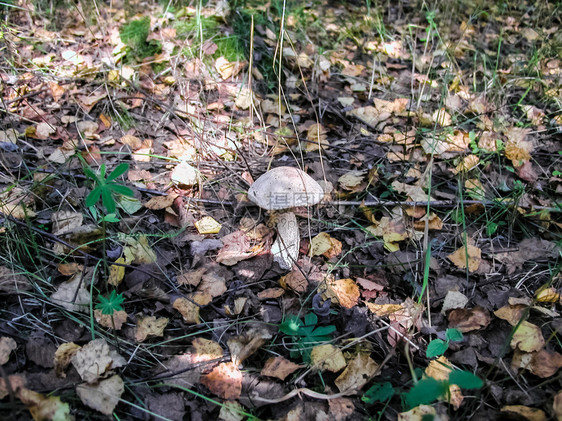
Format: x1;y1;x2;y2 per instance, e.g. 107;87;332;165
248;167;324;210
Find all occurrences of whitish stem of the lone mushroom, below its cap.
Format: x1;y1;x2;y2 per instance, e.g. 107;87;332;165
271;212;300;270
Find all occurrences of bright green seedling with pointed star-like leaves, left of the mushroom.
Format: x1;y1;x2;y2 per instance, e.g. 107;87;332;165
84;163;134;213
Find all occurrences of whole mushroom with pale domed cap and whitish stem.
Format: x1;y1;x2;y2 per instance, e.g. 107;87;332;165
248;167;324;270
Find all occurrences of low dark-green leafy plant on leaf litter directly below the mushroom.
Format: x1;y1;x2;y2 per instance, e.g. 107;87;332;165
279;313;336;362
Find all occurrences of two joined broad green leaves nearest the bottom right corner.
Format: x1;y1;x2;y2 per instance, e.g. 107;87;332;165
404;370;484;409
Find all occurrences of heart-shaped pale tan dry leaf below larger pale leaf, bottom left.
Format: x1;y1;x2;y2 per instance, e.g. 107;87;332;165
76;374;125;417
